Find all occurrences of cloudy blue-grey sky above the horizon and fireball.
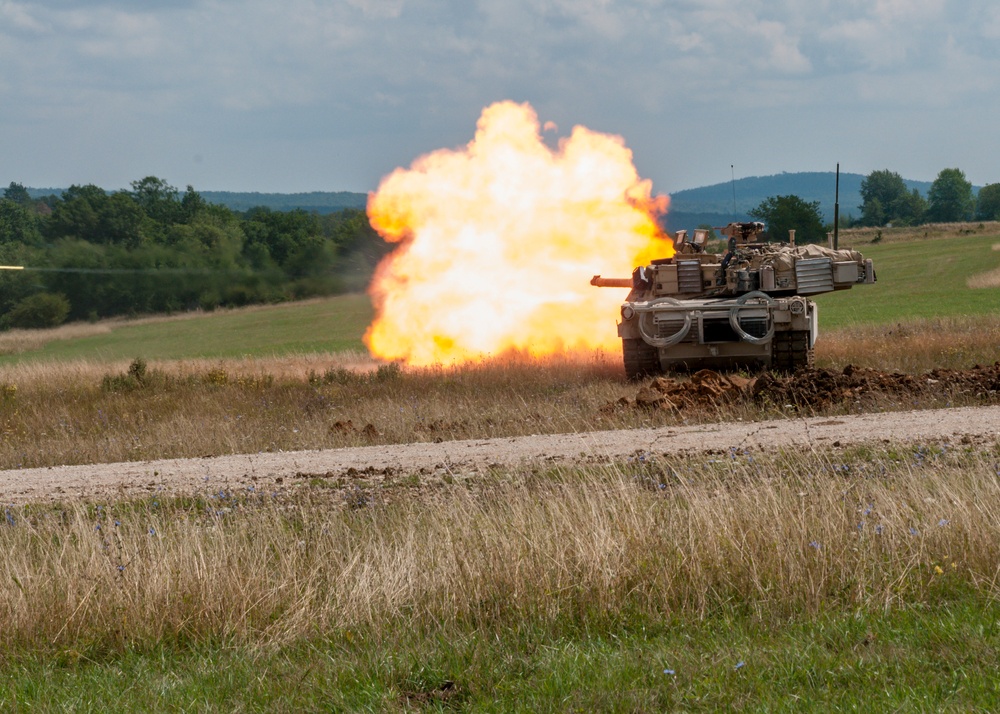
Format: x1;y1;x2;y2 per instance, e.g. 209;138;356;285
0;0;1000;193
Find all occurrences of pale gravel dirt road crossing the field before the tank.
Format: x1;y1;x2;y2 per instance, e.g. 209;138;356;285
0;406;1000;504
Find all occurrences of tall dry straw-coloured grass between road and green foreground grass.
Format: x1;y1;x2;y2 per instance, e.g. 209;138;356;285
0;445;1000;648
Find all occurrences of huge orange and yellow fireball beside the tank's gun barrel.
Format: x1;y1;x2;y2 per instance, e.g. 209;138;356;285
365;102;674;366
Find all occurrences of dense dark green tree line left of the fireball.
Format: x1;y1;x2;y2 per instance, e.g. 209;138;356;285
0;176;388;328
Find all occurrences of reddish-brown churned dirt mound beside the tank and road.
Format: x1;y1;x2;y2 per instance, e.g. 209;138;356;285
604;362;1000;412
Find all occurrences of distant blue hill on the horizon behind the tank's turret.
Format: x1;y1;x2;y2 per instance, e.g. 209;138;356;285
666;171;931;231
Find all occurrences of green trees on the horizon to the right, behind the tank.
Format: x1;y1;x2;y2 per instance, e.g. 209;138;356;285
749;169;1000;243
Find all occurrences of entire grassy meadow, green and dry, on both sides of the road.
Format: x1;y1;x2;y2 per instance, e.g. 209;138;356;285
0;224;1000;712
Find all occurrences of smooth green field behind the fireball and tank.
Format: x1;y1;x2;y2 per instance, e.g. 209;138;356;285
0;227;1000;364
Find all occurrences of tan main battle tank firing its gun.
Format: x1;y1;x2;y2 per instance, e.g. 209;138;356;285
590;223;875;378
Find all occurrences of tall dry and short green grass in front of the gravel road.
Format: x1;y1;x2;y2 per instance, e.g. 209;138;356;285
0;442;1000;711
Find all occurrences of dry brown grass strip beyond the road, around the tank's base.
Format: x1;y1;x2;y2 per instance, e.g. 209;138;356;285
0;318;1000;469
